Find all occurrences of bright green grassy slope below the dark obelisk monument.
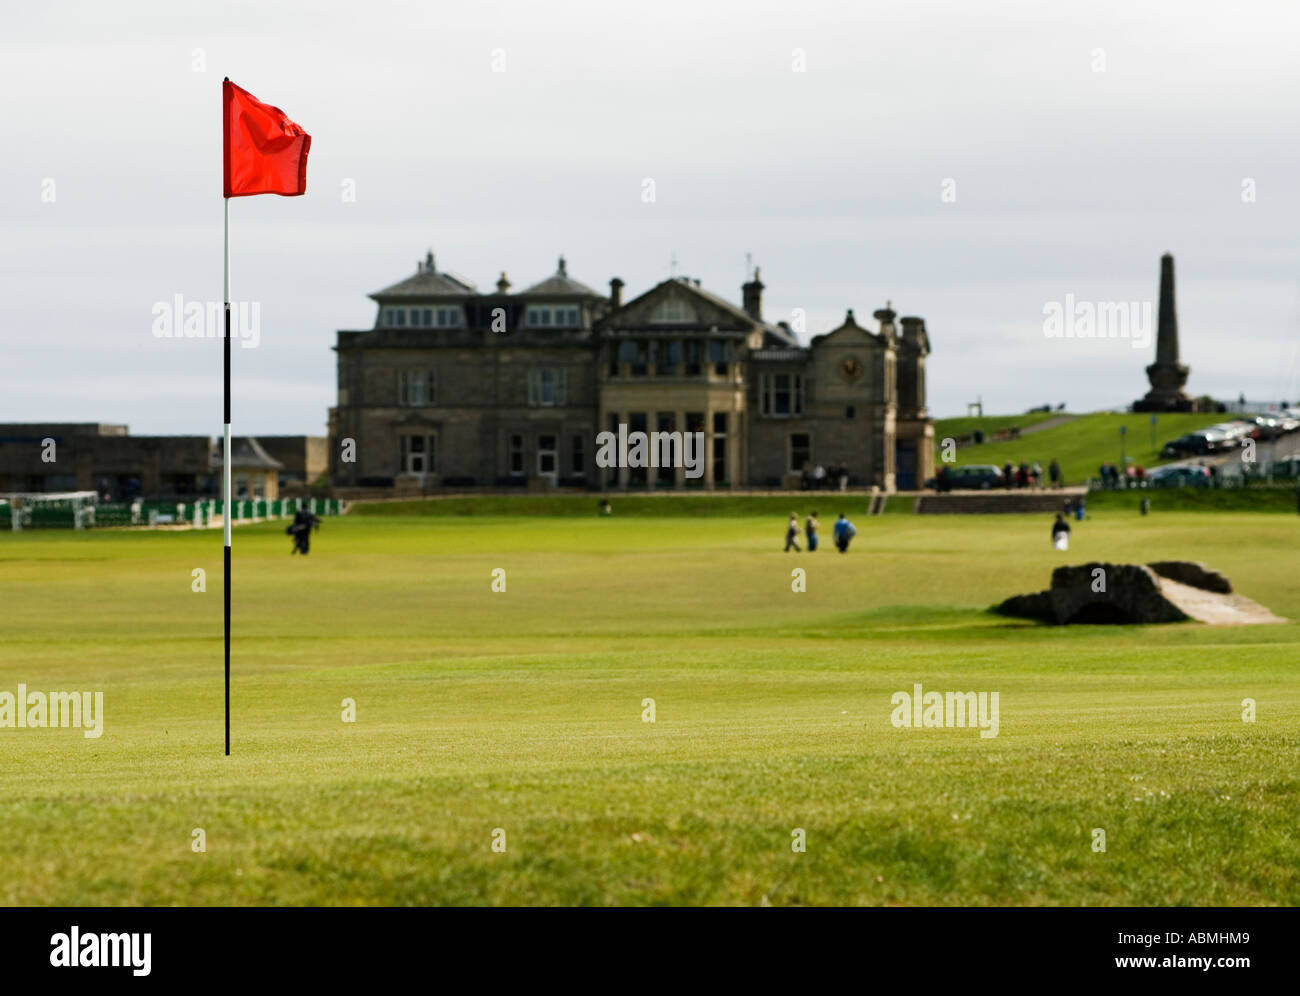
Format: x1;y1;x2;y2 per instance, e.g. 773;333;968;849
935;412;1231;484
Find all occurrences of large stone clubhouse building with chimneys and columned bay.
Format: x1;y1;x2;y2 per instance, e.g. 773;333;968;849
330;252;933;493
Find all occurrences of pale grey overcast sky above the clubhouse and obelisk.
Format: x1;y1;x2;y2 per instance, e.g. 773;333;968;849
0;0;1300;434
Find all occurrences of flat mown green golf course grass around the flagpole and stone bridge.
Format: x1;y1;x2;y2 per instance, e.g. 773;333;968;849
0;509;1300;905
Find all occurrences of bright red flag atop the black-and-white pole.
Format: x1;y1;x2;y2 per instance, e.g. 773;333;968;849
221;79;312;198
